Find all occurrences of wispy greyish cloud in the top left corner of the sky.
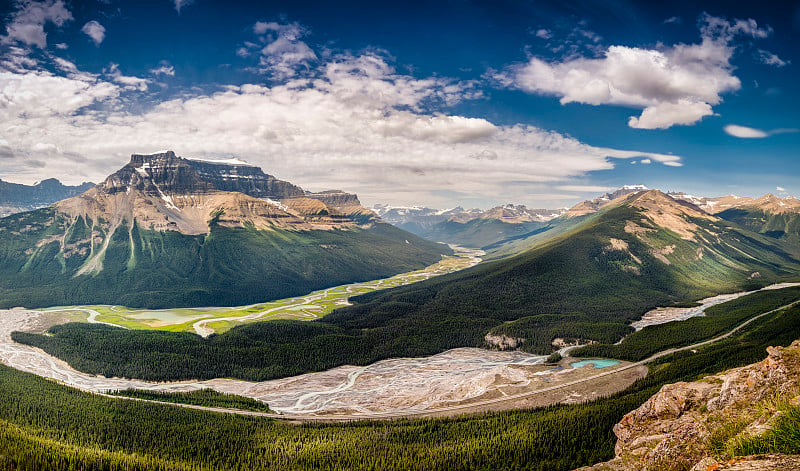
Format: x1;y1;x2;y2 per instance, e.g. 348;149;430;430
2;0;73;49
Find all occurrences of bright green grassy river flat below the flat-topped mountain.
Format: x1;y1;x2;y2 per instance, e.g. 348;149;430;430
40;250;480;337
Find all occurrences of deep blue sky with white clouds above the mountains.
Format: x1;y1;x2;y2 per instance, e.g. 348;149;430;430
0;0;800;208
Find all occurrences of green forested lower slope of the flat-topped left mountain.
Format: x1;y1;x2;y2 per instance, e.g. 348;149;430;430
0;208;450;308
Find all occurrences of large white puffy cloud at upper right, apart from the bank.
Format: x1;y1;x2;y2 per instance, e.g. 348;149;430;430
495;15;771;129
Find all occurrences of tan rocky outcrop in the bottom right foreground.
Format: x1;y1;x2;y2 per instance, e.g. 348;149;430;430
581;341;800;471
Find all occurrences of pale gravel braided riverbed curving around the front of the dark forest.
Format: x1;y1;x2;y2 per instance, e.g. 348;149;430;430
0;284;800;421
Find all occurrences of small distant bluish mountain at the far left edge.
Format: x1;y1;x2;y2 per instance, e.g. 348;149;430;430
0;178;94;218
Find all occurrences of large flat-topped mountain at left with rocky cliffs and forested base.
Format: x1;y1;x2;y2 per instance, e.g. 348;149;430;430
0;151;450;307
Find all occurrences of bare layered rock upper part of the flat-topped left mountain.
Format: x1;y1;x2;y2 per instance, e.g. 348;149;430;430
56;151;374;234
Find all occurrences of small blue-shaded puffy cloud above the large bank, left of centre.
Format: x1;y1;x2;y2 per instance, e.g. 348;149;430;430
236;21;317;80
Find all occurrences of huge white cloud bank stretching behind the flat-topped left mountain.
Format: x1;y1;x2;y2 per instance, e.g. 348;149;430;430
0;10;681;205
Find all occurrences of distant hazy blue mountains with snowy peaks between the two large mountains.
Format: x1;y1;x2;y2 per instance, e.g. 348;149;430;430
373;204;563;248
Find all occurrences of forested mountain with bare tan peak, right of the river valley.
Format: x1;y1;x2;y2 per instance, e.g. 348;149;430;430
312;190;800;355
